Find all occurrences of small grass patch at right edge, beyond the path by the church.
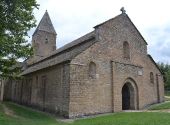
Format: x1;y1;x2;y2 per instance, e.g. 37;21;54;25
149;102;170;110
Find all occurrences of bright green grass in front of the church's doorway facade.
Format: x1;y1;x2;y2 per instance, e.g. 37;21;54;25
74;112;170;125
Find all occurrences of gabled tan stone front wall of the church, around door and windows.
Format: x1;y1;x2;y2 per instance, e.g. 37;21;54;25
69;14;164;117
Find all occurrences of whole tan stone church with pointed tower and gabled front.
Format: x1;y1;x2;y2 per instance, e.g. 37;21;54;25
4;10;164;118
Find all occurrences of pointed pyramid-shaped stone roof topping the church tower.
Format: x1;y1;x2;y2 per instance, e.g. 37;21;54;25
33;10;56;35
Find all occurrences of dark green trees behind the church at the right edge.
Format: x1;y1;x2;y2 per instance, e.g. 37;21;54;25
157;63;170;90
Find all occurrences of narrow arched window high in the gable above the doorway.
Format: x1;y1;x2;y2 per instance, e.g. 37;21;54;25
123;41;130;59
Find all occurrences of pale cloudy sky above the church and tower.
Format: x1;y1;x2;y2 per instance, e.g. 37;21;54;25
29;0;170;63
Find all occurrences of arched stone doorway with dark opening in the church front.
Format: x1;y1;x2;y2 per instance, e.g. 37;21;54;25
122;78;139;110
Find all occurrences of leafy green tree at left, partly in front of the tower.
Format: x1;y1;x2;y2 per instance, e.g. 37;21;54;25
0;0;38;77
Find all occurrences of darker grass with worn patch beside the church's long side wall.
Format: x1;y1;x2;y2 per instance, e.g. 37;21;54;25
0;102;64;125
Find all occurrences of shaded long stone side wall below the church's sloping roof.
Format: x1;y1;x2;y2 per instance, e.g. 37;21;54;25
5;63;69;117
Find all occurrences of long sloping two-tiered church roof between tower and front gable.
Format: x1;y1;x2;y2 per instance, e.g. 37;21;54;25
21;31;96;75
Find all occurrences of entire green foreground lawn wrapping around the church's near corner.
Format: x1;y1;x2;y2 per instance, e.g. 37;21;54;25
0;102;170;125
